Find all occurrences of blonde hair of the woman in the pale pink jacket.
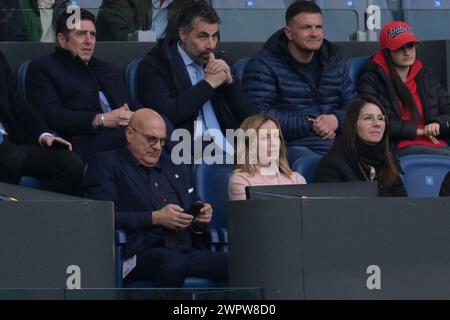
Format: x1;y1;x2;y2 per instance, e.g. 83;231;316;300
233;114;293;177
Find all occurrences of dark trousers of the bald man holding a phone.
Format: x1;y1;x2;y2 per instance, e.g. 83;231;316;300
124;248;228;288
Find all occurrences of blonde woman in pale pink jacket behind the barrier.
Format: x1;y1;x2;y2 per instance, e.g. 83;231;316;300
228;114;306;200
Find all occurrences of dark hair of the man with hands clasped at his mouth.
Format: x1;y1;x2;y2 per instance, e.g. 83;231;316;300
177;2;220;32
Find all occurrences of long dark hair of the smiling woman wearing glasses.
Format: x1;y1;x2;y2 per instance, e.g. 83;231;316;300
342;96;400;186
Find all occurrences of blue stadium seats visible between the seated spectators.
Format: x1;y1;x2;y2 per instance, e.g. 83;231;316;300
18;56;450;288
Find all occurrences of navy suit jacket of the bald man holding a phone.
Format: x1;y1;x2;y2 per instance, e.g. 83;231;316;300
84;148;209;256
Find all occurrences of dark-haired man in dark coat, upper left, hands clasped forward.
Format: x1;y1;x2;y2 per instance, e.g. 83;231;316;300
27;10;138;162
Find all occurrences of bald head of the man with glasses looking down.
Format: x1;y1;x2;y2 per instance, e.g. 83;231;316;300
125;108;166;167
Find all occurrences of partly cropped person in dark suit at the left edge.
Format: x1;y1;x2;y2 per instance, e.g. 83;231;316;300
0;52;83;193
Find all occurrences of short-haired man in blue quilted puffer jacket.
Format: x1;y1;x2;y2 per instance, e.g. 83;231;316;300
243;1;356;163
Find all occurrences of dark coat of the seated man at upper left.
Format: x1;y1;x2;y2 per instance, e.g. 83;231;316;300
26;47;139;158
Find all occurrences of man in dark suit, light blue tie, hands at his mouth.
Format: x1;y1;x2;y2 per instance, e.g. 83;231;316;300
138;3;256;156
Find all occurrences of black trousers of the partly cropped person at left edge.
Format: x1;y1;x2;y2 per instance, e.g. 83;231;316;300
0;139;83;194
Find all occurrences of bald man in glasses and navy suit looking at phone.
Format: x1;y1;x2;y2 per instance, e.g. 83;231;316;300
84;108;227;288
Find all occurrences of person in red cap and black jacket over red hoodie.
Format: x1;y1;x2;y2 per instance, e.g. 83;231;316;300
357;21;450;156
